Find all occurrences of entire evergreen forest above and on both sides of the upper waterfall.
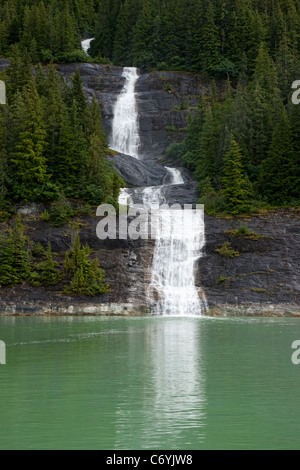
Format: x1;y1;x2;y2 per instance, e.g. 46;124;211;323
0;0;300;212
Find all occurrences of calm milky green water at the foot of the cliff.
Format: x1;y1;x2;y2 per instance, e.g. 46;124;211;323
0;317;300;450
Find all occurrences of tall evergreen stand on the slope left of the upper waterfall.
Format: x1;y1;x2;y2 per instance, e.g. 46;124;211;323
0;46;121;217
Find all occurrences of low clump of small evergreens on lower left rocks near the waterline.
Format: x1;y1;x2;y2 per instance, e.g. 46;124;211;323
0;215;110;296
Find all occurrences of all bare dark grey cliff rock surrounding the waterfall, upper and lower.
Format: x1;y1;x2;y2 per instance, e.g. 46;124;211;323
0;61;300;315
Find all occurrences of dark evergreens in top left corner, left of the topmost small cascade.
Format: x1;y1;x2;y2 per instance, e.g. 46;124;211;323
0;0;99;62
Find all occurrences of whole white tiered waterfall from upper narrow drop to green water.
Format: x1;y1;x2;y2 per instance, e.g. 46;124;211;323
110;67;207;316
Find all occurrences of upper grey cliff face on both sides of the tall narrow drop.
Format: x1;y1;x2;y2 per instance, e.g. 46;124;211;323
57;64;216;161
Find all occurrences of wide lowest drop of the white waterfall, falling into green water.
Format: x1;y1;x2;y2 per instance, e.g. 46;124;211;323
147;168;206;316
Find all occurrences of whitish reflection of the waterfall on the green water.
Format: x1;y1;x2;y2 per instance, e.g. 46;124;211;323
116;318;206;449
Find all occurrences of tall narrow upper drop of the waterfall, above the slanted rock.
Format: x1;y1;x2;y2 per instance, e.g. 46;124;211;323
110;67;140;158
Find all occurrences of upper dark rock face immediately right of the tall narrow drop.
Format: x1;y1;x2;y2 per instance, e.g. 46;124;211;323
136;72;216;160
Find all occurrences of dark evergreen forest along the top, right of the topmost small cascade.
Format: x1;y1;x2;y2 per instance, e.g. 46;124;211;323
91;0;300;77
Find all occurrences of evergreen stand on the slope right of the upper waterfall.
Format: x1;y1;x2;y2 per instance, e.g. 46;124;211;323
167;43;300;213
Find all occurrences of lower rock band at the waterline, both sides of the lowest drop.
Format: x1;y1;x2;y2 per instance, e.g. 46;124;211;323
0;208;300;315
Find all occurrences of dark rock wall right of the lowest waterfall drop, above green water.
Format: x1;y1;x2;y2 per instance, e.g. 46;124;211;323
196;210;300;313
